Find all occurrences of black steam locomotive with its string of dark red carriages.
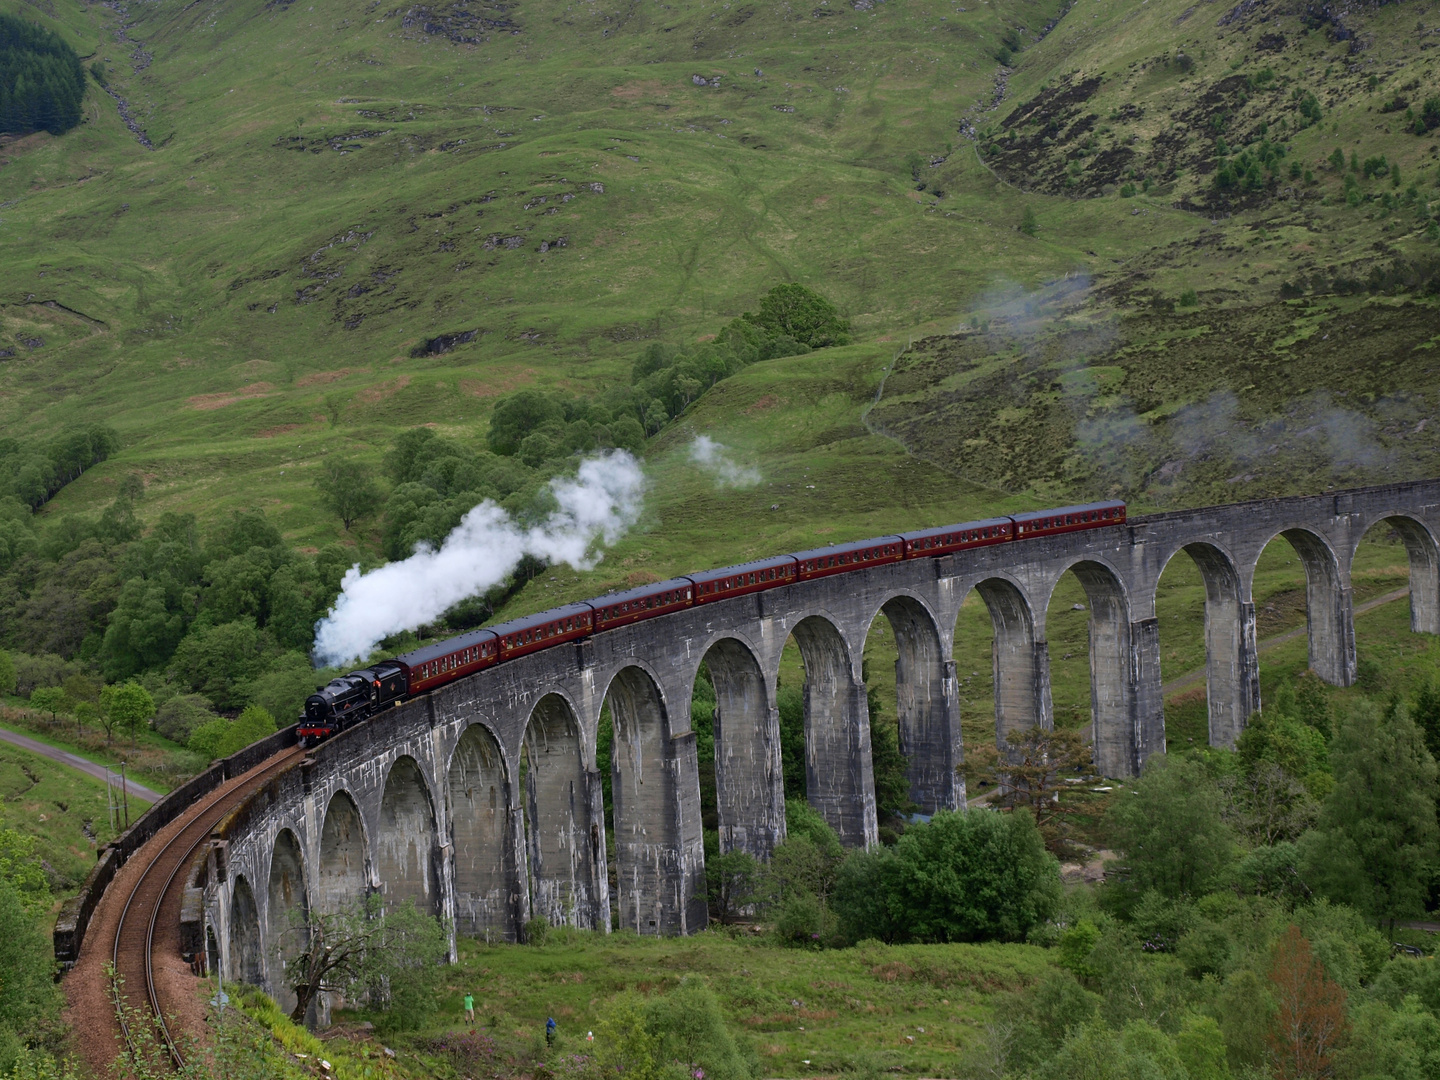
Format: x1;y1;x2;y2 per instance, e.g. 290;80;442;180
297;503;1125;746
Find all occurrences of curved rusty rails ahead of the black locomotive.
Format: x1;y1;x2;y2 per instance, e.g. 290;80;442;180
107;746;305;1068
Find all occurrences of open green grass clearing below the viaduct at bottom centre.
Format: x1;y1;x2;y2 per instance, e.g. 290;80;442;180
388;930;1050;1077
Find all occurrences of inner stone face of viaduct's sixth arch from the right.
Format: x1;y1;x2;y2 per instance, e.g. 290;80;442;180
871;593;965;814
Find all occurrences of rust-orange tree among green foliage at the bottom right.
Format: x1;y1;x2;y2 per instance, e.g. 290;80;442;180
1269;926;1345;1080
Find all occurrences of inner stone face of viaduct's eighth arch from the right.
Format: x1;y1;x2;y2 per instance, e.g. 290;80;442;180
691;638;785;858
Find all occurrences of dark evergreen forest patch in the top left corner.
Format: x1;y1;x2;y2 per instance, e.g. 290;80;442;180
0;14;85;135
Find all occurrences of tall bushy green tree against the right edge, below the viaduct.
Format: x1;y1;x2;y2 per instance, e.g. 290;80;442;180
1306;701;1440;927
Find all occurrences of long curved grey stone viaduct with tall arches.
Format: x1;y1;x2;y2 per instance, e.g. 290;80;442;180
189;480;1440;999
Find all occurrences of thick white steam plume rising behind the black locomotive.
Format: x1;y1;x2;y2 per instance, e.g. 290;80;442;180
315;451;645;665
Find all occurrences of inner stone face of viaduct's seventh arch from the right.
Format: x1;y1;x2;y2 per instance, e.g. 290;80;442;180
791;615;880;848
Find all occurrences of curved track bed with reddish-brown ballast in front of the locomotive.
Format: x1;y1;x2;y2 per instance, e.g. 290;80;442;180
66;746;305;1074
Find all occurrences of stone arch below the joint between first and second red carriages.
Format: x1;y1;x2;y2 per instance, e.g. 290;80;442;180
449;724;520;939
